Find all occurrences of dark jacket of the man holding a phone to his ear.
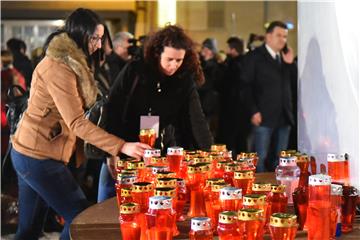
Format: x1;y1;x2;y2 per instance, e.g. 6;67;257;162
241;45;296;128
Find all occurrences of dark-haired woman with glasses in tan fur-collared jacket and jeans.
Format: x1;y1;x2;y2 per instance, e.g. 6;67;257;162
11;9;150;240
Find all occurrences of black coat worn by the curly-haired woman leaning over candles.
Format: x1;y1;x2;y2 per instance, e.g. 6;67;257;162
107;60;213;150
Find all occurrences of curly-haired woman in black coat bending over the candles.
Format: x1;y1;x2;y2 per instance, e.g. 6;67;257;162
98;26;213;201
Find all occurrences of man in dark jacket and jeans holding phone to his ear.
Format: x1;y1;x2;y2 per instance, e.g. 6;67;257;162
242;21;296;172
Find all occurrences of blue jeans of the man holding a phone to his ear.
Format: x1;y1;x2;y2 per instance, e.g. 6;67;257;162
253;125;291;172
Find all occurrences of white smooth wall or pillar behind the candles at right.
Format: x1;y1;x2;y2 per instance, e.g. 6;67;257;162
298;0;360;187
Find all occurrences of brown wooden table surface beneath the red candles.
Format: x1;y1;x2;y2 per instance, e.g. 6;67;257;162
70;173;360;240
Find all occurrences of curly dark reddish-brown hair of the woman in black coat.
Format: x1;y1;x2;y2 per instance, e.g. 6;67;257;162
144;25;205;86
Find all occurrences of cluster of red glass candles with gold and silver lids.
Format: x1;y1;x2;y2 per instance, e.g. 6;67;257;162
116;145;353;240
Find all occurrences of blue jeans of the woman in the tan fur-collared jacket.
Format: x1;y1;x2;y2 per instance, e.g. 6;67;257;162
11;149;89;240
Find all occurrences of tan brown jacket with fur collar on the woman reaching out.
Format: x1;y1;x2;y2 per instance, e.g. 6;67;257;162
12;33;124;163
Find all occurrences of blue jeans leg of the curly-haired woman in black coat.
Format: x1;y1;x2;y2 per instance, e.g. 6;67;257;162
98;162;116;202
